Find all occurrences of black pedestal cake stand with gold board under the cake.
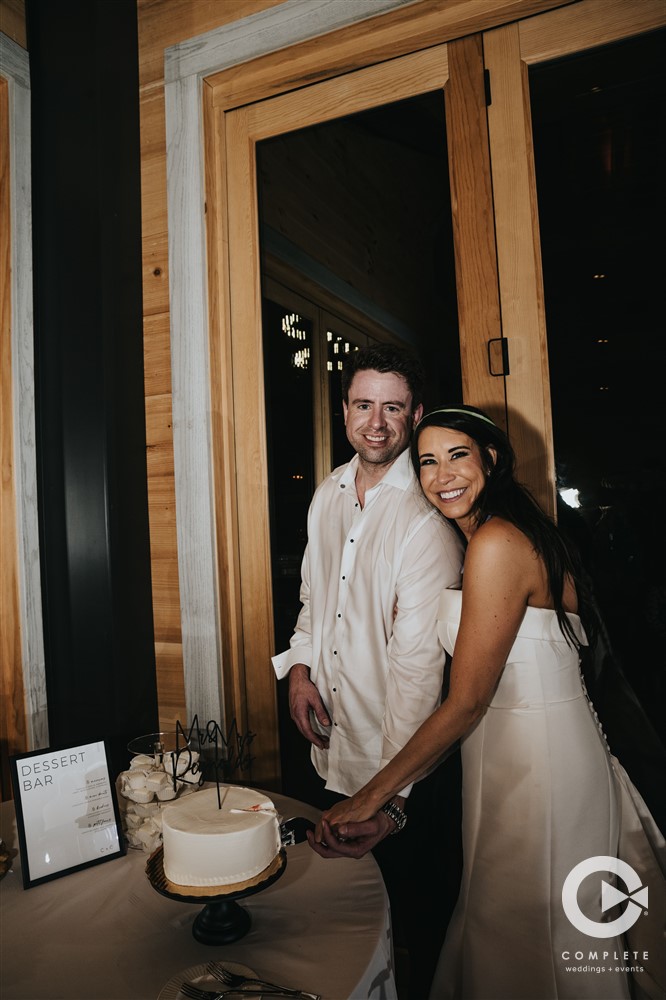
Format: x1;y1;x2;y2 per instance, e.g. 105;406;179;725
146;847;287;945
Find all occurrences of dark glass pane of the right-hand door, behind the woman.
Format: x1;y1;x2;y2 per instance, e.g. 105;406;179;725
530;32;666;772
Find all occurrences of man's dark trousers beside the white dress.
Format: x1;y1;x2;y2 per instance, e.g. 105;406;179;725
316;751;462;1000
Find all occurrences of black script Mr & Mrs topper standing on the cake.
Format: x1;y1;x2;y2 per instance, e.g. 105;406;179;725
155;715;255;808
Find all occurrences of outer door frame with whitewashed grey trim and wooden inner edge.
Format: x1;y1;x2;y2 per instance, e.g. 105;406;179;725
165;0;588;784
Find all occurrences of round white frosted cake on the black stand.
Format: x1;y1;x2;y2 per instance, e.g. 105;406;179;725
162;785;282;886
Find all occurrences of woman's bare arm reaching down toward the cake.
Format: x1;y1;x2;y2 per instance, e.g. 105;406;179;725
315;518;539;850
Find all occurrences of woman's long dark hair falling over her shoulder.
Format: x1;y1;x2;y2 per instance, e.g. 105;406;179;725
412;404;593;649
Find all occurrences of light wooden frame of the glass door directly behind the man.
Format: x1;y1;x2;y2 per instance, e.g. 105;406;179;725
205;35;505;784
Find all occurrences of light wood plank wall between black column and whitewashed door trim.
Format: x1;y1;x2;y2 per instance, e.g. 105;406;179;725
138;0;280;729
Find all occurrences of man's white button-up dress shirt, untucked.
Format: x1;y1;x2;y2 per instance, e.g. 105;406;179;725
273;450;463;795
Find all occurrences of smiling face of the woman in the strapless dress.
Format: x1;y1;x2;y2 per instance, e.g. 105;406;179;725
418;427;492;538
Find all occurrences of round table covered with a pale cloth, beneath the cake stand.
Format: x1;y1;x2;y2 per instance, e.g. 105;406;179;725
0;793;397;1000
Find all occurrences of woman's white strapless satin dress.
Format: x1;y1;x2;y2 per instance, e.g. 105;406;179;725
431;591;665;1000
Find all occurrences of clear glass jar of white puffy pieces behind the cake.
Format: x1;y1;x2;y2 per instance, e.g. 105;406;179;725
116;733;201;854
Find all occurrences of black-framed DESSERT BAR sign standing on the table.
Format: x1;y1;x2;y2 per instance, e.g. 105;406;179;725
11;742;125;889
